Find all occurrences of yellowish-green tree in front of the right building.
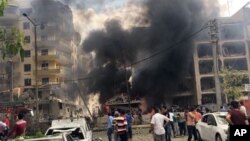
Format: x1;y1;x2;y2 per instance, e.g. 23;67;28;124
221;68;248;100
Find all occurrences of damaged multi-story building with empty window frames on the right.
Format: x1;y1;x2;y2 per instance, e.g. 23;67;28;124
193;3;250;107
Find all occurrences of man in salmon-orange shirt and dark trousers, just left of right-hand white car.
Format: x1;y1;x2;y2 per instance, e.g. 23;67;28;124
187;107;198;141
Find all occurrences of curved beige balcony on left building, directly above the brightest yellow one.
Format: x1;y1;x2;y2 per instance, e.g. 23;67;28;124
37;54;73;66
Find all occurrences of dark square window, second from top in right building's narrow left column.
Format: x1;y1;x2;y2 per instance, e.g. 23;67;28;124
199;60;214;74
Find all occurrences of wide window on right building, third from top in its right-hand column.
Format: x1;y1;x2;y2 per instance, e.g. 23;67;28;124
224;58;247;70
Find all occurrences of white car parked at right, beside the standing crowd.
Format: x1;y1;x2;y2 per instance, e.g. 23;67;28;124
196;113;229;141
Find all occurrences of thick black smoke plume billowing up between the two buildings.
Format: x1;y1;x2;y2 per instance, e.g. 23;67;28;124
82;0;219;105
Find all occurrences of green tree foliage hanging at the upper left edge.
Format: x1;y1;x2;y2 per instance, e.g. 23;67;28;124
0;28;24;61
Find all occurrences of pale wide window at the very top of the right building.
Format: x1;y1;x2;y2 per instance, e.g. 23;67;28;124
221;24;244;40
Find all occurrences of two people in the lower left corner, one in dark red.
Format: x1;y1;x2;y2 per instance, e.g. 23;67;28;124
0;113;27;141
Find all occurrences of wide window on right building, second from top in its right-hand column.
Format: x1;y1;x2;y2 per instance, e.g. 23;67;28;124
222;42;246;57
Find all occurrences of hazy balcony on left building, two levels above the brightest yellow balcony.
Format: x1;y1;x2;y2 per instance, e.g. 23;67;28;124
37;40;73;53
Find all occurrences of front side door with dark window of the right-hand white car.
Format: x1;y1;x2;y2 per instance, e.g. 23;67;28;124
206;114;217;141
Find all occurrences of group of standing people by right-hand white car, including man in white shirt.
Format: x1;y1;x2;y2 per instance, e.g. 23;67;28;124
150;106;202;141
